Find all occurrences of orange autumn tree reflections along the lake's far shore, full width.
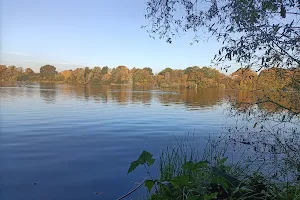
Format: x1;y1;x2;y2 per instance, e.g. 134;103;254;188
1;84;300;112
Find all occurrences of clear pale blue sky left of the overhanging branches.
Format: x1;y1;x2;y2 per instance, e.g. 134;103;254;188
0;0;236;72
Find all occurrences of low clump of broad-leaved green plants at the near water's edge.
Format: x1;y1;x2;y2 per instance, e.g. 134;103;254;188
128;146;300;200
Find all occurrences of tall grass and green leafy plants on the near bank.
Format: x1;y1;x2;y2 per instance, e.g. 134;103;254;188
126;138;300;200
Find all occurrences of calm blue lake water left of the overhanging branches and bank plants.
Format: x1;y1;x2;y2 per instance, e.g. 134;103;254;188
0;85;237;200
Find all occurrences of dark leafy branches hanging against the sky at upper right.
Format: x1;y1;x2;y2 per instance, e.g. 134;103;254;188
145;0;300;68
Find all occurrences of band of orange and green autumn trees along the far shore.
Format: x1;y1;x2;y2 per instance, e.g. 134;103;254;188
0;65;300;90
